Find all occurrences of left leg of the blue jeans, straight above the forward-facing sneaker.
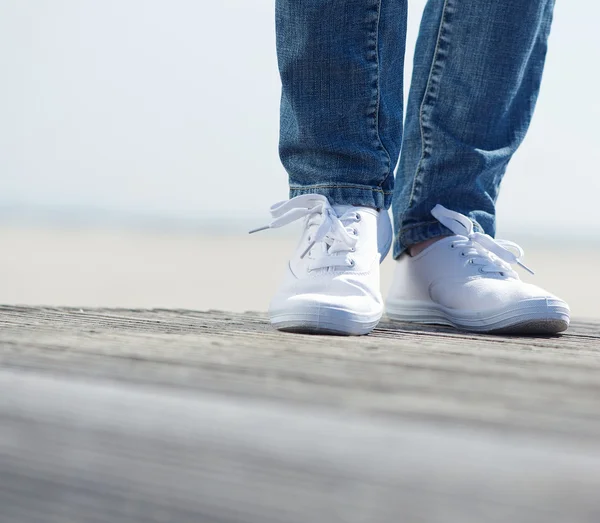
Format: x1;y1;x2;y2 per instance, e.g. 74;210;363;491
276;0;407;209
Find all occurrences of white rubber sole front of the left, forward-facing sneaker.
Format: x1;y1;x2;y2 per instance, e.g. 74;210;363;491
269;307;383;336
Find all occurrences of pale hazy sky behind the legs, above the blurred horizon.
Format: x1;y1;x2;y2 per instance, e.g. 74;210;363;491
0;0;600;237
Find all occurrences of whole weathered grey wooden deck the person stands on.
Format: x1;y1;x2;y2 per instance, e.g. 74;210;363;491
0;306;600;523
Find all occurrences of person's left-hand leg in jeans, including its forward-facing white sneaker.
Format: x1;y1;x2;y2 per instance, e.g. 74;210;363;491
256;0;406;334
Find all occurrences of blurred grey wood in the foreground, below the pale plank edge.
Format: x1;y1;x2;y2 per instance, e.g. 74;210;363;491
0;371;600;523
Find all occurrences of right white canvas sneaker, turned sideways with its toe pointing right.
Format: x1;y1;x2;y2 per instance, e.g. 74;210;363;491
386;205;569;334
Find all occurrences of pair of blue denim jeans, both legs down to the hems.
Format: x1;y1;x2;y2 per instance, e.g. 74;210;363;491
276;0;554;257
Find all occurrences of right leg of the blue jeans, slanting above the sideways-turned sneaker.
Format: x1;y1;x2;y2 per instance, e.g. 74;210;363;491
393;0;554;257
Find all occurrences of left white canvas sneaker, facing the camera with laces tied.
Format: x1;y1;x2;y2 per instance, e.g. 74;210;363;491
251;194;392;335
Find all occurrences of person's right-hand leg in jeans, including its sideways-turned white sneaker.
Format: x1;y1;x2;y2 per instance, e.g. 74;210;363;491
387;0;569;334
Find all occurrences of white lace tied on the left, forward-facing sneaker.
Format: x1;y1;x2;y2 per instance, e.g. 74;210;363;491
250;194;360;271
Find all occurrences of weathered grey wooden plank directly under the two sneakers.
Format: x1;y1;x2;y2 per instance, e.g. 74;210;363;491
0;308;600;437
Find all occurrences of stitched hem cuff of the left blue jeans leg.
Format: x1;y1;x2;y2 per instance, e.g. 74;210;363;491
290;184;392;210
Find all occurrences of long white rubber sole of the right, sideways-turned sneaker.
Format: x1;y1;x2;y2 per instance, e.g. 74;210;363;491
386;298;570;335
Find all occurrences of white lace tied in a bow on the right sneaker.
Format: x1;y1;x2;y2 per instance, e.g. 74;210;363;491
431;204;534;277
